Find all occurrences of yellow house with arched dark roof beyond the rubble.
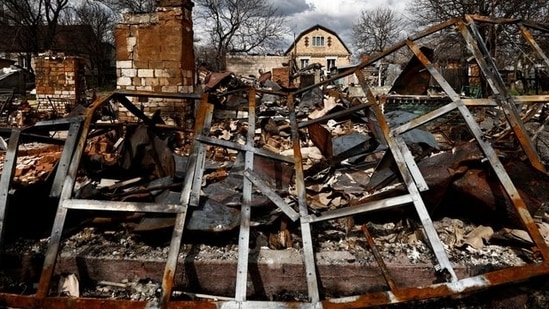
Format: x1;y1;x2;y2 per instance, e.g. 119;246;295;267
285;25;351;74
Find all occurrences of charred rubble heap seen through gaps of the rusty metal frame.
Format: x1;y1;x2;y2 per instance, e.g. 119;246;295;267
0;70;549;299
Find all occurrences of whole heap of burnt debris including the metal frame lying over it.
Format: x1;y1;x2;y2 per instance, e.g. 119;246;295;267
0;14;549;307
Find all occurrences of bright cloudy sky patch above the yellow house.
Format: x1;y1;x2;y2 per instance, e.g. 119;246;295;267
270;0;410;49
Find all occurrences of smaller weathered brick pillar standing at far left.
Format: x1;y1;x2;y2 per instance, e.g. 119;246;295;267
34;54;85;114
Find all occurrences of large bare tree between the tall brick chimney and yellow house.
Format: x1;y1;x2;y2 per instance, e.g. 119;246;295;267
195;0;289;71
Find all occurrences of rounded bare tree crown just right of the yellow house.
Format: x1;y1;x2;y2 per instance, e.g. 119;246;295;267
353;7;403;55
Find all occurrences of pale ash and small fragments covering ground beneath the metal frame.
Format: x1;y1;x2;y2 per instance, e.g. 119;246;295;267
1;217;549;308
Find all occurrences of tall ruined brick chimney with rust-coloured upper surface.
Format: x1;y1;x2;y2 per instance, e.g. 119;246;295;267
115;0;195;125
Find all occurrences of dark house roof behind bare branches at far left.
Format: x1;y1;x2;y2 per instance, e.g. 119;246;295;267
0;25;95;55
